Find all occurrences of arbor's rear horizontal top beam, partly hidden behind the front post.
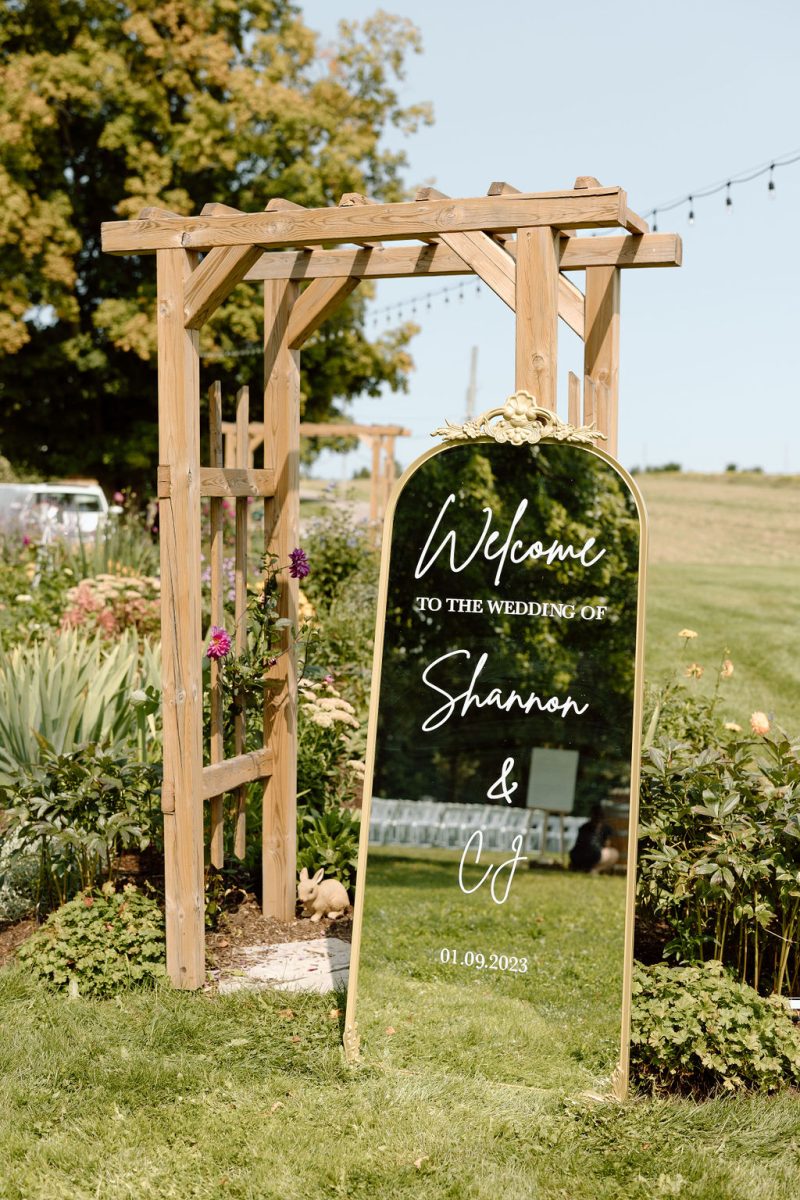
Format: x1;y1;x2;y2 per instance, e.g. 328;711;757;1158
245;233;682;282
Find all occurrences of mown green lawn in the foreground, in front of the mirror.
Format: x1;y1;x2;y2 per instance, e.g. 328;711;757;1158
0;971;800;1200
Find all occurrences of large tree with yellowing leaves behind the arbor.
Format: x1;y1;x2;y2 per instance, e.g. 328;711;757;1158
0;0;428;485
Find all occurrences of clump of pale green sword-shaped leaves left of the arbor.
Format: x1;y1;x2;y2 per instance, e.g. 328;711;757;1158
0;630;161;785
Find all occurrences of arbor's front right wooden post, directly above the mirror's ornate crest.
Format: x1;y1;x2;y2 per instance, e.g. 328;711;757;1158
516;227;559;412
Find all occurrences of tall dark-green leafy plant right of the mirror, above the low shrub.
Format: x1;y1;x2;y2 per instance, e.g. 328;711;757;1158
638;702;800;994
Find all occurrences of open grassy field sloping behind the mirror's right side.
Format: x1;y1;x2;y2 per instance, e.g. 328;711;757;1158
638;472;800;732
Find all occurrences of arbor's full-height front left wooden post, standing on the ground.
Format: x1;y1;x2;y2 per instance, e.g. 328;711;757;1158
156;250;205;988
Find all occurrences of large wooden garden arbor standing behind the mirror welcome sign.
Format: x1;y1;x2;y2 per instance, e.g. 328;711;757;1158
102;178;680;988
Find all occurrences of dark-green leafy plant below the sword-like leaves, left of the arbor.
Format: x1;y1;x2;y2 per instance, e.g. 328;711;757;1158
0;744;161;910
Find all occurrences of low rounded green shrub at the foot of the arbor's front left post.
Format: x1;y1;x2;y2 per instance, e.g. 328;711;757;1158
17;886;166;998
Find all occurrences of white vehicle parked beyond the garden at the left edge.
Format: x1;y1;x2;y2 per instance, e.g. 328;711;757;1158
0;484;115;540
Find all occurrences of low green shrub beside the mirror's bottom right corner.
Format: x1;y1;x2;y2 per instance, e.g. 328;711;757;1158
631;961;800;1096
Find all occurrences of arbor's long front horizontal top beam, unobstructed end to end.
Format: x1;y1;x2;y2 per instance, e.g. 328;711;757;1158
102;187;630;254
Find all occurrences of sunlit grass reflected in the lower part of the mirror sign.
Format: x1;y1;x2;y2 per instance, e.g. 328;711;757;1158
357;852;625;1092
